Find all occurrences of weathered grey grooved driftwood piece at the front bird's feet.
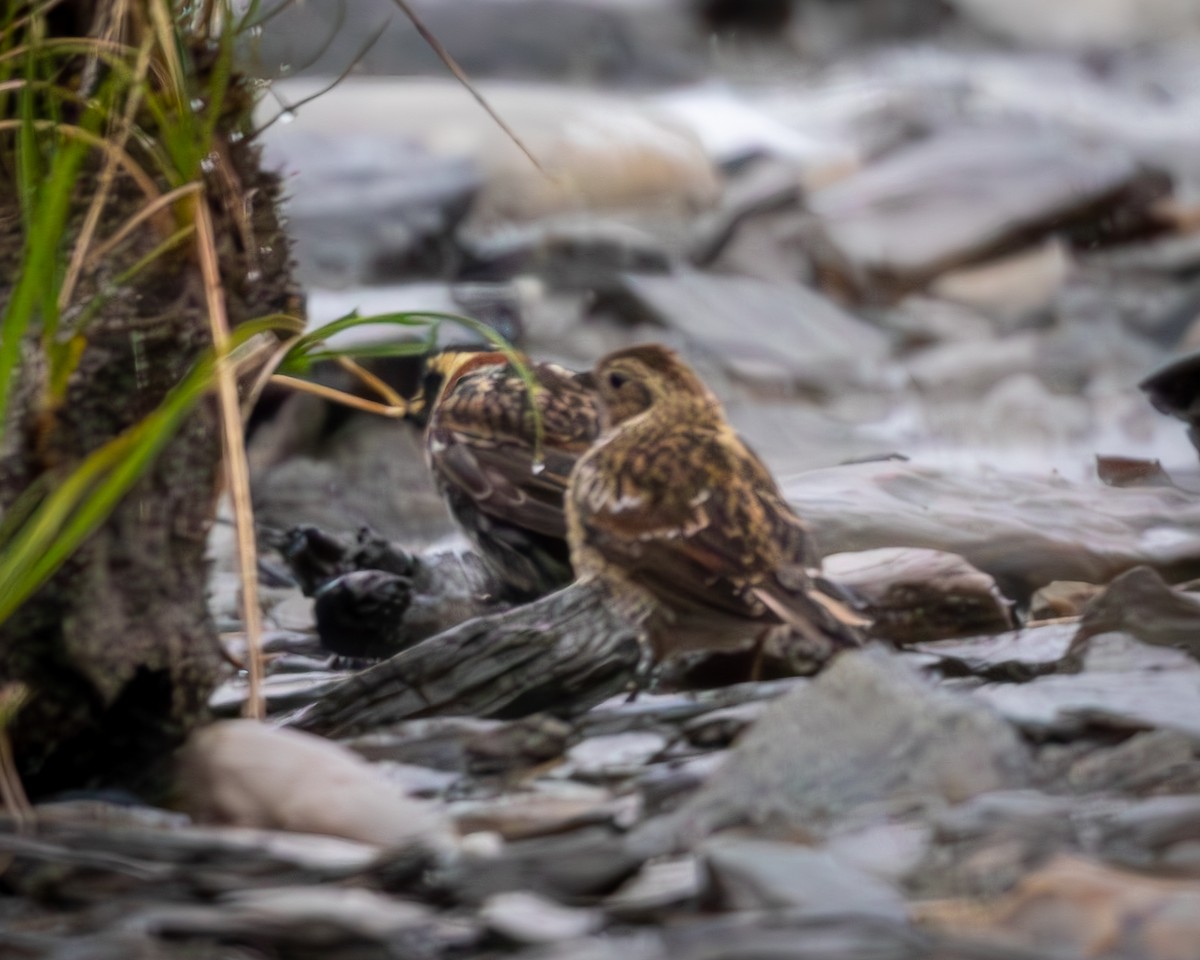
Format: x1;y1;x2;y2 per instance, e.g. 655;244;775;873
293;583;641;736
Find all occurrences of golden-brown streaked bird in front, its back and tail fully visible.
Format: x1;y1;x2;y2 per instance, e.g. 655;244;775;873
566;344;862;670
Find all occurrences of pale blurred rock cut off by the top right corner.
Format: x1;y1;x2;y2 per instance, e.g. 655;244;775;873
952;0;1200;50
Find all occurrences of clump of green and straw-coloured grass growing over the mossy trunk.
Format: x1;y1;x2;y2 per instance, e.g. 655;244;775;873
0;0;541;744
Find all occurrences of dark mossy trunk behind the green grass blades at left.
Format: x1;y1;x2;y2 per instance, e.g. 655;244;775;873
0;0;296;797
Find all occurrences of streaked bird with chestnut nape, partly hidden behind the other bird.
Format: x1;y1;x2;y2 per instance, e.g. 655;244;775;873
410;349;600;599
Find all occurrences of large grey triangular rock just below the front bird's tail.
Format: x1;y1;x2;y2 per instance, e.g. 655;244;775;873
632;649;1027;848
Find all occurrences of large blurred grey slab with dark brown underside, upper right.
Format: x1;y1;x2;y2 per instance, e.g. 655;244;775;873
810;126;1139;289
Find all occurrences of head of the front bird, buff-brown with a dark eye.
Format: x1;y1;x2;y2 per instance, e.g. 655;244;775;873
595;343;719;427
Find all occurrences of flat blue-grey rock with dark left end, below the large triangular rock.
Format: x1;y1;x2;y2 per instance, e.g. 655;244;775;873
701;838;907;920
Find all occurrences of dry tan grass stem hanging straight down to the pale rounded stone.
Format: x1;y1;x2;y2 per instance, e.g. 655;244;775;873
193;194;265;720
